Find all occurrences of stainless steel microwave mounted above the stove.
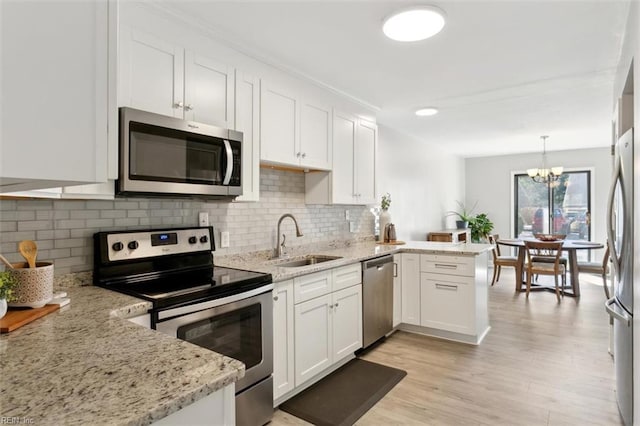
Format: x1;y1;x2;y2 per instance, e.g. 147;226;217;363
116;107;242;198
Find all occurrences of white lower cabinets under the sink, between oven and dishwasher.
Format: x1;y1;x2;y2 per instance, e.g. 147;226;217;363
273;263;362;405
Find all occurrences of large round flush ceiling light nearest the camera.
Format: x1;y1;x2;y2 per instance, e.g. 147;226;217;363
382;6;445;41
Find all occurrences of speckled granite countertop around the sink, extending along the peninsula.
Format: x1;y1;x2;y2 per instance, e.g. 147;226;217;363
214;241;492;282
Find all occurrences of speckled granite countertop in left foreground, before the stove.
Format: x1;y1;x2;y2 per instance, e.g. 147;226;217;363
0;286;244;425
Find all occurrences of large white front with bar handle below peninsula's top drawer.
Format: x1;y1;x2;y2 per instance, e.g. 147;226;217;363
420;273;476;334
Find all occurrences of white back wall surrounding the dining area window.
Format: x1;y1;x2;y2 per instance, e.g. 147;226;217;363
466;148;611;248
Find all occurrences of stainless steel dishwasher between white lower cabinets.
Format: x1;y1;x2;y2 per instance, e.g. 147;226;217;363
362;256;393;348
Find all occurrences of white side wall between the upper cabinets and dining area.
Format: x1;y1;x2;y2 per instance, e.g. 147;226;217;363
377;125;465;241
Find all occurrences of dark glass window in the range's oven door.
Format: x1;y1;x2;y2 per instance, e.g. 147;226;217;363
177;303;262;370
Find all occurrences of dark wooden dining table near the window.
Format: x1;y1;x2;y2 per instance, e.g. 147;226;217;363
496;237;604;297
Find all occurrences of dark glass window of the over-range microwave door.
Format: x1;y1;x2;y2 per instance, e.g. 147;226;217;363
129;122;223;185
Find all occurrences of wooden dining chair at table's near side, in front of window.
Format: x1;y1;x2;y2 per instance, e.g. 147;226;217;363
524;241;567;302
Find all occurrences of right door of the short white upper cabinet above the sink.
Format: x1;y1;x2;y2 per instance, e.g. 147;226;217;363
299;99;332;170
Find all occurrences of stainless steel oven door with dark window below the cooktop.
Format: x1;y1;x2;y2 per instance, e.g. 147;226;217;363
155;284;273;393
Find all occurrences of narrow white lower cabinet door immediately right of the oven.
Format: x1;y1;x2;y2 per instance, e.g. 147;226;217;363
273;280;295;399
